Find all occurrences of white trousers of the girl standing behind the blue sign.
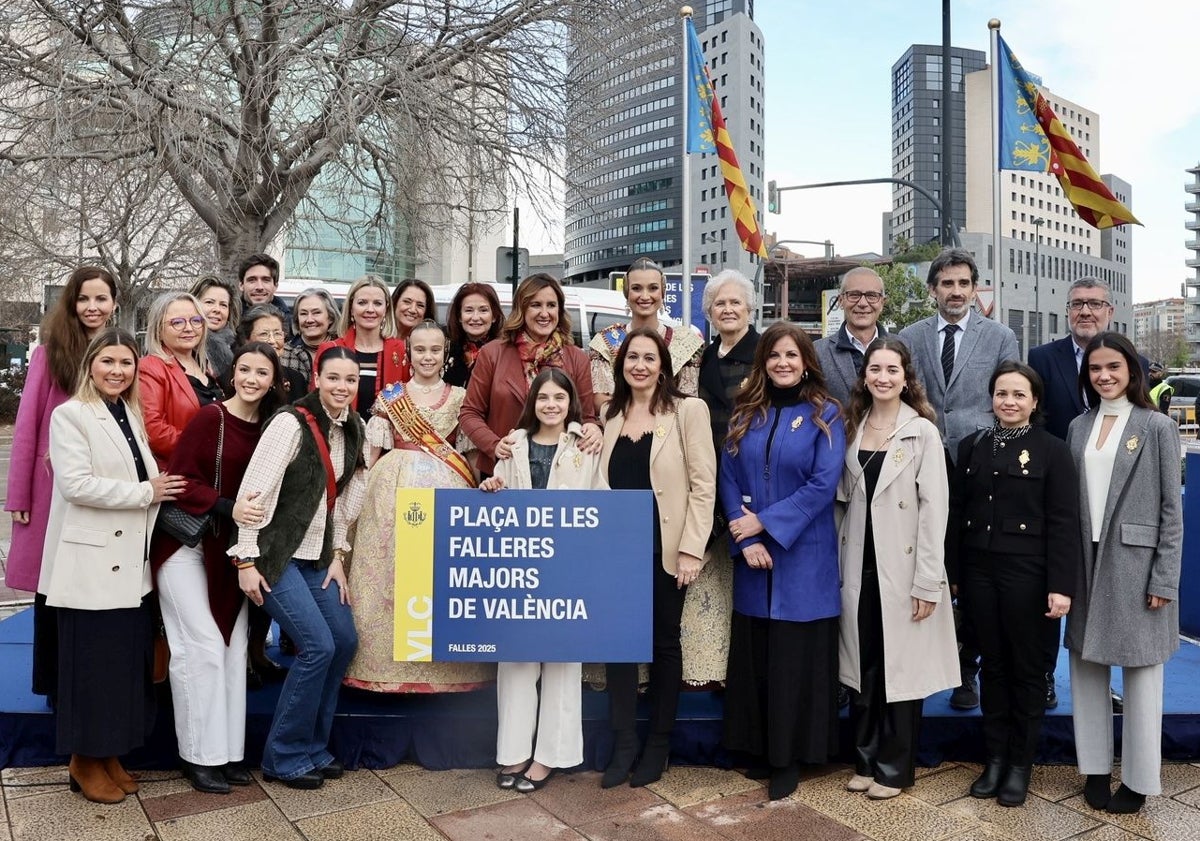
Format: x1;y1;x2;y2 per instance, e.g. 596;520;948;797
496;663;583;768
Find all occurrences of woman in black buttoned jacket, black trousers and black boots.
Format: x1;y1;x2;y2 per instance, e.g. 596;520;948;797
946;360;1082;806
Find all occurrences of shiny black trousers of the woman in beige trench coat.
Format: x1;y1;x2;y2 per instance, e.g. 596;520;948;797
850;569;924;788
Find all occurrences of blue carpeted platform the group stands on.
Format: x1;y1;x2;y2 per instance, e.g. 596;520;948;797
0;611;1200;769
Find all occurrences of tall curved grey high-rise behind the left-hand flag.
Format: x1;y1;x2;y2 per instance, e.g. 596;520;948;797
564;0;764;282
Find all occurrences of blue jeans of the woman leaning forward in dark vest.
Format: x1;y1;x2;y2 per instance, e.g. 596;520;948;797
263;558;359;780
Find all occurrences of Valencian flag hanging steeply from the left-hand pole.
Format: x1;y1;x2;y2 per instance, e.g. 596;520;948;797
685;18;767;258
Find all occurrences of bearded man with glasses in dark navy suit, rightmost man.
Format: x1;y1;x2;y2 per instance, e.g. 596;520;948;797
1030;277;1150;710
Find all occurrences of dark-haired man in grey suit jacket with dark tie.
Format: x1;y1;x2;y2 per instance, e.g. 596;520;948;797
900;248;1020;709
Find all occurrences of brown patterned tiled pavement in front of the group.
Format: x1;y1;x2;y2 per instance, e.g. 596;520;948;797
0;427;1200;841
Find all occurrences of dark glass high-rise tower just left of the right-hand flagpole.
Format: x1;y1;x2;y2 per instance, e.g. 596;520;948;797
884;44;988;253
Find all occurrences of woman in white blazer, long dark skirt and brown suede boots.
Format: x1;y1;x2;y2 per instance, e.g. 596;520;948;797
37;328;184;803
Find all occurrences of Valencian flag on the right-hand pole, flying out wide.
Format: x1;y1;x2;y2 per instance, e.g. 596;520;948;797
997;38;1141;228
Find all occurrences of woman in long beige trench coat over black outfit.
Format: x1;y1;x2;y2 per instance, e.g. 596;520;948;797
838;337;960;799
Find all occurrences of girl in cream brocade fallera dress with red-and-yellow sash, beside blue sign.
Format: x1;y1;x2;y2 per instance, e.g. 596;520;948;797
346;322;496;692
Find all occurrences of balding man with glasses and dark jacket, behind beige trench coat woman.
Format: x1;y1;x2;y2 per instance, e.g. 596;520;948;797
816;266;888;406
